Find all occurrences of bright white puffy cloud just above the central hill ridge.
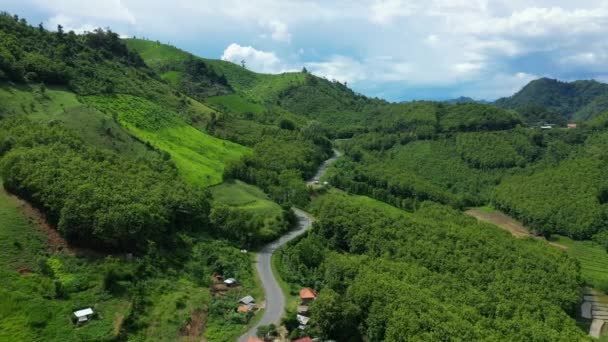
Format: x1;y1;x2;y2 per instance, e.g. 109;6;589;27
221;43;284;73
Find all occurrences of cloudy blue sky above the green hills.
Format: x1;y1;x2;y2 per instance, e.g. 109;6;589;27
0;0;608;101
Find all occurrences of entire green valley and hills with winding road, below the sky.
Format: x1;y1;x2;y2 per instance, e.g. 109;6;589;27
0;9;608;342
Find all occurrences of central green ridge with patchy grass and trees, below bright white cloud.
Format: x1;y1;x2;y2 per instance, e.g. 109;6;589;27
126;39;386;136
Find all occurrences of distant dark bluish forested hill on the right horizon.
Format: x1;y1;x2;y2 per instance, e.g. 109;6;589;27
495;78;608;124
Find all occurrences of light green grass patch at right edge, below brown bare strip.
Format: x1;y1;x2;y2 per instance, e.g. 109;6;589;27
552;235;608;292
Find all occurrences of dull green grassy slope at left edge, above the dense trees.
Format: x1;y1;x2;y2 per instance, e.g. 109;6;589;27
0;84;155;157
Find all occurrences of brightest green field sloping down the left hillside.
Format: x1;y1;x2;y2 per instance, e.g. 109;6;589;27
86;95;249;186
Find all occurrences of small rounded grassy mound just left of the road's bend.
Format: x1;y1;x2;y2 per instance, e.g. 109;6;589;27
210;180;287;241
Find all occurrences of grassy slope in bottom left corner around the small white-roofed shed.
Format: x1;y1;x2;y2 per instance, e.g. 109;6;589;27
0;190;130;341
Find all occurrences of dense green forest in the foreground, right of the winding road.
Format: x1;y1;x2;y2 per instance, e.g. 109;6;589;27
280;192;583;341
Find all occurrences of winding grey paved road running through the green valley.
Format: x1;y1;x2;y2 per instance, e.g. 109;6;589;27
238;149;342;342
